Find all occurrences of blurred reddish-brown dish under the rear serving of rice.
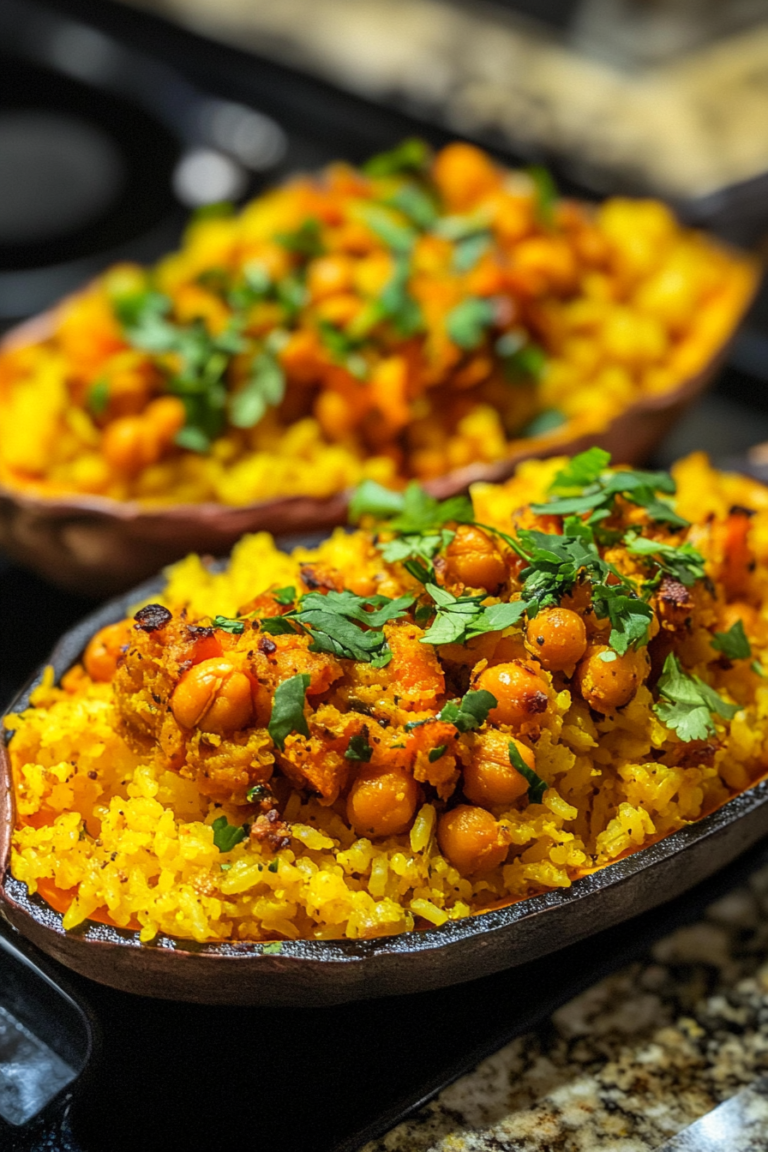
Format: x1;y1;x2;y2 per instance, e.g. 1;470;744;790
0;269;756;596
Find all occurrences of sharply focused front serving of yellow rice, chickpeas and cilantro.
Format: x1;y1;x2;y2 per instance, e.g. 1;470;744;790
5;448;768;947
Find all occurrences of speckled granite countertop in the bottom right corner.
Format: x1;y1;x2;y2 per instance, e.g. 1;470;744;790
365;869;768;1152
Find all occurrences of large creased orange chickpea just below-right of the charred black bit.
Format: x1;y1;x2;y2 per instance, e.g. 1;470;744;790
170;658;253;735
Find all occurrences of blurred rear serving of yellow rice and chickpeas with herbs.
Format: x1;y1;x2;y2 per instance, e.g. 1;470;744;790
0;141;755;505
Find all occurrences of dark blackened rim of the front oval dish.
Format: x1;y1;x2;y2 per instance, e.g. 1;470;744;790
6;560;768;964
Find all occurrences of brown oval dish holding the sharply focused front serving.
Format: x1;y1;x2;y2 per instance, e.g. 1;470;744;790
0;577;768;1006
